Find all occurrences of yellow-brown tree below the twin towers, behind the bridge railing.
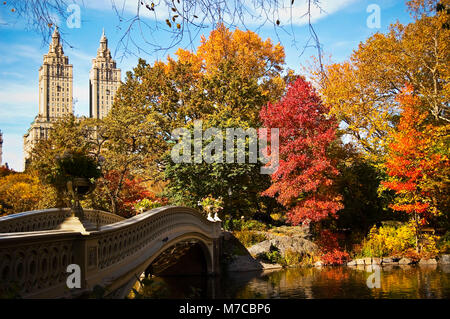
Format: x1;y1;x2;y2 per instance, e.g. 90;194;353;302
28;114;156;216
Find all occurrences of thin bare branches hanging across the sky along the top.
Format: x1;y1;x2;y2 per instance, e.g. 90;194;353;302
6;0;323;71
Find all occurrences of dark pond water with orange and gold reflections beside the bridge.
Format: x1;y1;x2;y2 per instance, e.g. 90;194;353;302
140;265;450;299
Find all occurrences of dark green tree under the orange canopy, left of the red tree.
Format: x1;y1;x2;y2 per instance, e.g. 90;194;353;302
165;118;280;219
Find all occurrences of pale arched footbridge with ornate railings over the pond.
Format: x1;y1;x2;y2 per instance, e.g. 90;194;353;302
0;206;221;298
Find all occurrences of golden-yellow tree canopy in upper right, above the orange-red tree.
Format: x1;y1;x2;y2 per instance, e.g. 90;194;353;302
313;0;450;162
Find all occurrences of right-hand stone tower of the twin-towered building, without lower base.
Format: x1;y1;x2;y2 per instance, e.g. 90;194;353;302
89;30;121;119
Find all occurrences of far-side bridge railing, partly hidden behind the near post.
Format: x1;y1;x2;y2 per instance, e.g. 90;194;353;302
0;208;125;233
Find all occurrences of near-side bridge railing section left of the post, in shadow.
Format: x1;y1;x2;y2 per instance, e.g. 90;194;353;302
0;231;81;298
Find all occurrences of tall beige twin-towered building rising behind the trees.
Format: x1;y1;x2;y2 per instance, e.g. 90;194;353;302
23;28;121;163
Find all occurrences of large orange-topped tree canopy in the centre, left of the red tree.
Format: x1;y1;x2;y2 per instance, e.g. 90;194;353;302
117;26;284;162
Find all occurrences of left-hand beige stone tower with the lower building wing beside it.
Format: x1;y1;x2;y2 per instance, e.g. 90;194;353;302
23;27;73;163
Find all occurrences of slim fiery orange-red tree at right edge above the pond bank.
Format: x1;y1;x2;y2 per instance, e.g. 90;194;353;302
382;87;450;250
